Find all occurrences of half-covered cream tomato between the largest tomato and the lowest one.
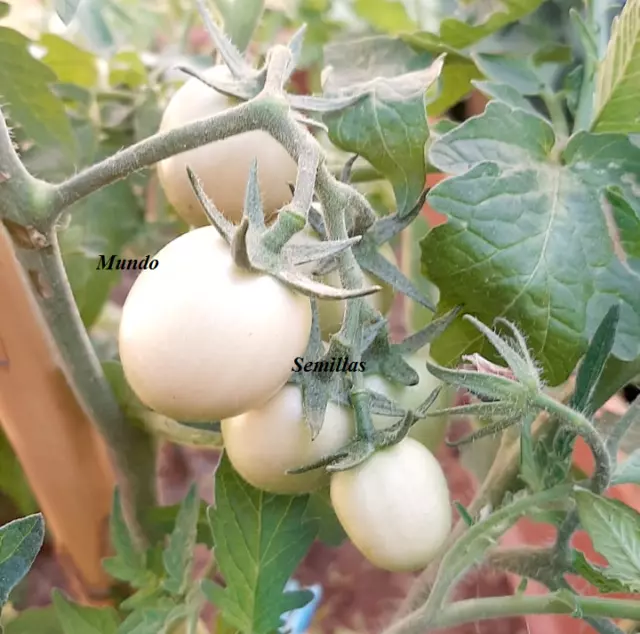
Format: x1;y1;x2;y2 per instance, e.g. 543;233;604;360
222;385;354;495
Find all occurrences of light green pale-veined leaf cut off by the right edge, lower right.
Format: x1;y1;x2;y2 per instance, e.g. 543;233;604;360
575;491;640;592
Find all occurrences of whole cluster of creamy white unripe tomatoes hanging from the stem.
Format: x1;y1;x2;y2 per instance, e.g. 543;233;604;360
119;66;451;570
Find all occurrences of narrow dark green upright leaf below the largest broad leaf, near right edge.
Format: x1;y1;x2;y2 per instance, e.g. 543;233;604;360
570;304;620;416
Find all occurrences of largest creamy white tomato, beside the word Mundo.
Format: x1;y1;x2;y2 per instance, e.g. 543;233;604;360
119;227;311;422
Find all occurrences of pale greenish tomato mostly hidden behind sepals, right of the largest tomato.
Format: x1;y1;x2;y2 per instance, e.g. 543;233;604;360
290;228;397;339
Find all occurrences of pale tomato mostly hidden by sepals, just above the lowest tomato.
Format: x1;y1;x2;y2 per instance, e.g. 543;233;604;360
364;351;453;451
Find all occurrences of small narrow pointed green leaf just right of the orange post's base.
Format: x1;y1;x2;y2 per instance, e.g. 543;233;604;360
102;488;149;587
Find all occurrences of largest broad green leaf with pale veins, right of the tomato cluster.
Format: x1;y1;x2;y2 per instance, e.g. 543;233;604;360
421;101;640;385
